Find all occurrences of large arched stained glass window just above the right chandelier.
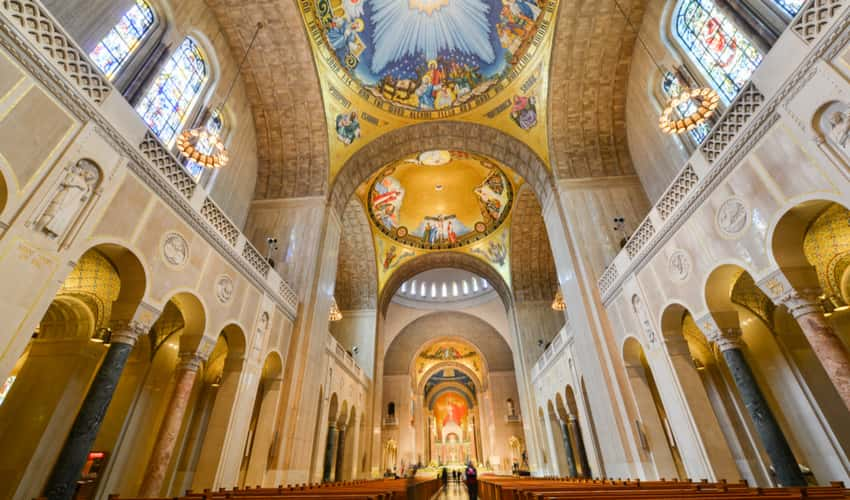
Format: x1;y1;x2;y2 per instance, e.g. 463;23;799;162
676;0;762;102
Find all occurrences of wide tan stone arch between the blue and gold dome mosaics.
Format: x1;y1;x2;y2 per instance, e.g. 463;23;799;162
328;121;555;218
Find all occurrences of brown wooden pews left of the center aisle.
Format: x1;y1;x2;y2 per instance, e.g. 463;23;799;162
99;478;440;500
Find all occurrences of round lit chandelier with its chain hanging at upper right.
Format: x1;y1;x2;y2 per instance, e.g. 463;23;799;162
614;0;720;135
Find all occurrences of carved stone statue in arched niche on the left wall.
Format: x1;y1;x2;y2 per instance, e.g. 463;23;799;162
35;160;100;239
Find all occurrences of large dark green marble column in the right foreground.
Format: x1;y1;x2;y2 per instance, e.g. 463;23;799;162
708;328;806;486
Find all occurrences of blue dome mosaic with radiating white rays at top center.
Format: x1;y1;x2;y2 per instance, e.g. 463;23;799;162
310;0;556;118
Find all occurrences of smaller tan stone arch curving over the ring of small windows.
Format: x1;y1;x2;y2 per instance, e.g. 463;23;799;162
378;252;513;316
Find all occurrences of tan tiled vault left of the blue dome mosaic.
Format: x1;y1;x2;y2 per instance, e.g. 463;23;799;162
206;0;328;199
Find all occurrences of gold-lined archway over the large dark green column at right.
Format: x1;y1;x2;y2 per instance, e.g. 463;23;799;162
705;264;847;485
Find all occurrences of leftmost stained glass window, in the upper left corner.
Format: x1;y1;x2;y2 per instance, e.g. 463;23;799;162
89;0;154;80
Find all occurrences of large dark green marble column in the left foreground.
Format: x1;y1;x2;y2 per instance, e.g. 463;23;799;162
44;321;147;500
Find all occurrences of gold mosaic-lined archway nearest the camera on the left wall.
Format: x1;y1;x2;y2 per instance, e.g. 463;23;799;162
0;244;148;498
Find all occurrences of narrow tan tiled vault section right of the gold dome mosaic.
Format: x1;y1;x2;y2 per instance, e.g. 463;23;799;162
511;188;558;302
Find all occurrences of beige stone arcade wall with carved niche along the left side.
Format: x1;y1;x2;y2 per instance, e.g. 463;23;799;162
0;5;295;498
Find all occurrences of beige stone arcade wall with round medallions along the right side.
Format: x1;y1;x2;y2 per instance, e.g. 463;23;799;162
600;5;850;484
